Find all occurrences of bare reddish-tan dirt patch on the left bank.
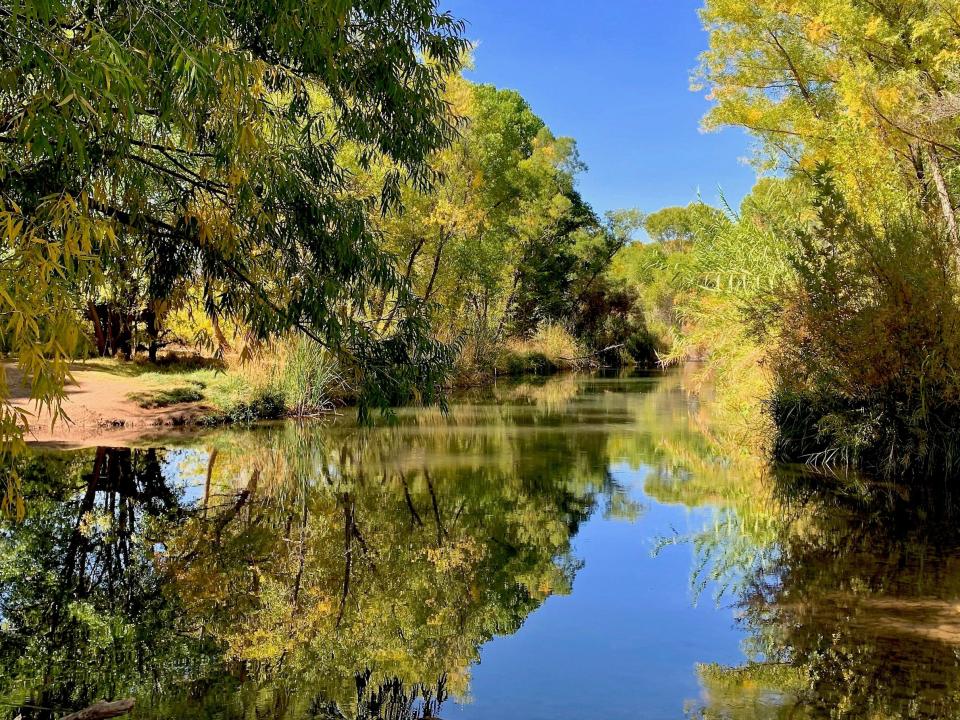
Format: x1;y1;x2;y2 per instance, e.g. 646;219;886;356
6;365;204;447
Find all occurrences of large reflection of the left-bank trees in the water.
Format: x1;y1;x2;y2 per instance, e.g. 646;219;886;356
0;394;636;720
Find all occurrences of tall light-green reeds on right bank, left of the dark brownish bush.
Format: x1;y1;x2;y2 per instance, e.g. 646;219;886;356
662;180;807;455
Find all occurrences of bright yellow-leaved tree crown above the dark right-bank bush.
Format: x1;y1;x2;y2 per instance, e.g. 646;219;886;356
696;0;960;238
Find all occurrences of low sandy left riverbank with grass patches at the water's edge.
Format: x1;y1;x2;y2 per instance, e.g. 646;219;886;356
6;356;624;449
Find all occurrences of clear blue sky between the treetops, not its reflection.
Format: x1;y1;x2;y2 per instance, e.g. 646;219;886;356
441;0;754;218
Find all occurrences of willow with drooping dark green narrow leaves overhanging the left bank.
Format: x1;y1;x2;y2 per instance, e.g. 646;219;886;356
0;0;466;464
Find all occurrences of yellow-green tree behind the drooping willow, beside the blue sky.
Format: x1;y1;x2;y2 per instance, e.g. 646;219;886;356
374;77;596;358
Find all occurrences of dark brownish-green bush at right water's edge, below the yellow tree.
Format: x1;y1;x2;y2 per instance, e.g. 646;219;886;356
770;184;960;476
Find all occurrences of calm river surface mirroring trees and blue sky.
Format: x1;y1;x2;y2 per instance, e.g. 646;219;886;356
0;375;960;720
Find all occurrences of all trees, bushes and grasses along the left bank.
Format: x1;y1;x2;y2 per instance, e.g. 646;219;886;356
0;0;655;470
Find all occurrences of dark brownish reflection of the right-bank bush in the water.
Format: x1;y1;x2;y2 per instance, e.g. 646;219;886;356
692;469;960;719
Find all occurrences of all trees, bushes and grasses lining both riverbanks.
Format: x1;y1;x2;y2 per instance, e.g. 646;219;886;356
9;0;960;486
